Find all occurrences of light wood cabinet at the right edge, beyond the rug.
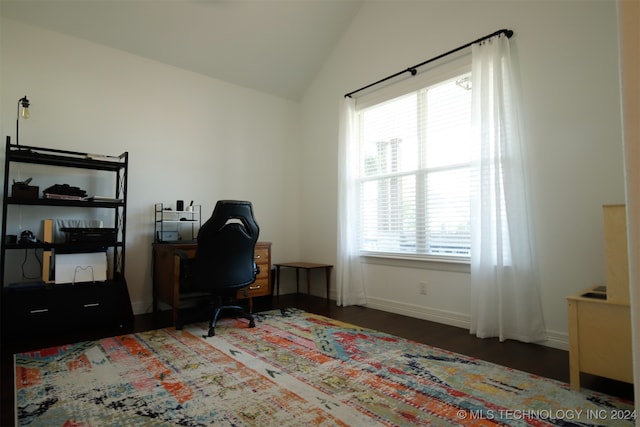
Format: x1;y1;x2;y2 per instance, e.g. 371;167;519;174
567;289;633;390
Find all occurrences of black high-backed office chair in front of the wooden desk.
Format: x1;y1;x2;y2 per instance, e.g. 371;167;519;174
181;200;260;337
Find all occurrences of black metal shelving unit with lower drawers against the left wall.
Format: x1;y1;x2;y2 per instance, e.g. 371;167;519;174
0;141;133;337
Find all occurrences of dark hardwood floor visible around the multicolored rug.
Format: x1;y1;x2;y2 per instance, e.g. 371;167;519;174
0;294;633;426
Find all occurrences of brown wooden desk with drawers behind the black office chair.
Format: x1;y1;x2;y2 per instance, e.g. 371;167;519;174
152;242;271;324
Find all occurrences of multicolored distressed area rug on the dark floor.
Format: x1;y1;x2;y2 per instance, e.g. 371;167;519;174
15;310;635;427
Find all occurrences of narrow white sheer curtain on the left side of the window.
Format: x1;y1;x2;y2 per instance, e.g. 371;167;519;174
336;97;367;306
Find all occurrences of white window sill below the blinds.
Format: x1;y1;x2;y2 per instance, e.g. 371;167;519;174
360;252;471;274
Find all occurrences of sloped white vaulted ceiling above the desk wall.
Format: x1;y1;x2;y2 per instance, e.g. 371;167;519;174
0;0;361;100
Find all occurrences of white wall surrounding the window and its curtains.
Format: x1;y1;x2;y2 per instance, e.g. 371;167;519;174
300;0;624;347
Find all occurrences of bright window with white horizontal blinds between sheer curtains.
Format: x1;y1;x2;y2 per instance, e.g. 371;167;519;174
356;68;471;260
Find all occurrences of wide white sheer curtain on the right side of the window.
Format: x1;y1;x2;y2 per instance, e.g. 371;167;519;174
470;35;545;342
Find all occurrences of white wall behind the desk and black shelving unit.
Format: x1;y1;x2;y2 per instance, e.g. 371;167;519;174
0;19;300;313
